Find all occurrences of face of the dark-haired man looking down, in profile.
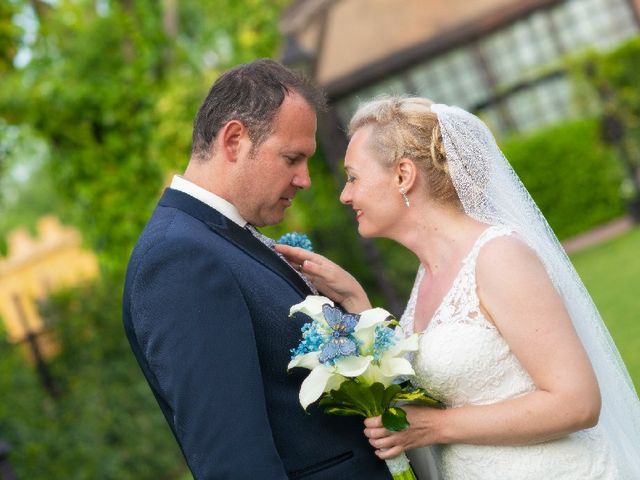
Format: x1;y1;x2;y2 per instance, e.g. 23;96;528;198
234;93;316;226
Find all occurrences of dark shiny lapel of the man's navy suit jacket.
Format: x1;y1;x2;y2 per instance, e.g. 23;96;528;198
158;188;311;297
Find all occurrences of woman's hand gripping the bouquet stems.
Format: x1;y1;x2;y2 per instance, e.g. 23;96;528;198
364;405;445;460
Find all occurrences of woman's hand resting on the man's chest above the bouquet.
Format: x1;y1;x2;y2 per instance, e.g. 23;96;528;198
275;244;371;313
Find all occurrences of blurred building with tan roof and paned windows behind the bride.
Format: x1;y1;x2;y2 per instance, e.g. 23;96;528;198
281;0;640;147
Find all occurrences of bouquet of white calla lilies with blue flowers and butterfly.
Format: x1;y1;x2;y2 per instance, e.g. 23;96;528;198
288;295;443;480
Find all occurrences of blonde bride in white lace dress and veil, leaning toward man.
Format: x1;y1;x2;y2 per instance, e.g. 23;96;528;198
277;97;640;480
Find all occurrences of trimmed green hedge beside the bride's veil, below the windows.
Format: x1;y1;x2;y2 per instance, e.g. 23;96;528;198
501;119;624;239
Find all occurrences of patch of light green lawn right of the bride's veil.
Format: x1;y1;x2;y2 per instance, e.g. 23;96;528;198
571;227;640;391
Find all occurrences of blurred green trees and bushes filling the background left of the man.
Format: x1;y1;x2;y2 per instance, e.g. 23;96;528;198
0;0;296;480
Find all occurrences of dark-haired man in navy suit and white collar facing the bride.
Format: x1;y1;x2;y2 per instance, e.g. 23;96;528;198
123;60;390;480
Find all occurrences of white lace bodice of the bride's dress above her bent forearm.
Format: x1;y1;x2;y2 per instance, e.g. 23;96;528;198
402;227;535;407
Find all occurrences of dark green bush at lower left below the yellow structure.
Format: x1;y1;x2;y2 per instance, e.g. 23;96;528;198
0;281;186;480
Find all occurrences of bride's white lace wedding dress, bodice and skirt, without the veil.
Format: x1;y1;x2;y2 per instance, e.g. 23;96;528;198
401;226;621;480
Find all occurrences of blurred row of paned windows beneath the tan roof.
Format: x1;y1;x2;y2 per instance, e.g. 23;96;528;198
337;0;638;137
